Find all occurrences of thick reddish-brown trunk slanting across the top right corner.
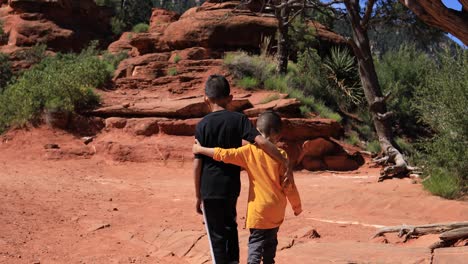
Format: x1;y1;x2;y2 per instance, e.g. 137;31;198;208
400;0;468;45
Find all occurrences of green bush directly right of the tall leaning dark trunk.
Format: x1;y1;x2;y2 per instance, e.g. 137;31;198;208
375;45;435;137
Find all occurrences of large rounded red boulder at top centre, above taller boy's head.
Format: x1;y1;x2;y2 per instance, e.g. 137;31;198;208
164;2;276;50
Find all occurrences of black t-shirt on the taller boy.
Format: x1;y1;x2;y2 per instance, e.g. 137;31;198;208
195;110;260;199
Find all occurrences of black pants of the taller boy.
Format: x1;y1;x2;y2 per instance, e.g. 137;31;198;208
203;197;239;264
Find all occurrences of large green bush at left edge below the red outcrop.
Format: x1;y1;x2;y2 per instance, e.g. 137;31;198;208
0;46;122;131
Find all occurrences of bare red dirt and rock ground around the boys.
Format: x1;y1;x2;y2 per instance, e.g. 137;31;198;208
0;138;468;263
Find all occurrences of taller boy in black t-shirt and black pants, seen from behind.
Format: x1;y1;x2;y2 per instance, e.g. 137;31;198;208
194;75;288;264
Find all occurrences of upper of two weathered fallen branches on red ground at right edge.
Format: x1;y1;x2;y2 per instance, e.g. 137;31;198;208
373;222;468;241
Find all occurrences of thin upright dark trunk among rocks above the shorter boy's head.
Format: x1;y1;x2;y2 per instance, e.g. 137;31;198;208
275;0;289;74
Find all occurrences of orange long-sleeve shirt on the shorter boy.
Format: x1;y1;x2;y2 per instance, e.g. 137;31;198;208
213;144;302;229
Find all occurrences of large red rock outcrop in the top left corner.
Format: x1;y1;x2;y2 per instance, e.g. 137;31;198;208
0;0;111;51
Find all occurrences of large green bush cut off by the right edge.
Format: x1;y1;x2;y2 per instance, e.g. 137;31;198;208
414;49;468;198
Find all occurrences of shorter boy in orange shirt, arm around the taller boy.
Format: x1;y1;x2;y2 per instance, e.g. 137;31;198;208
193;111;302;264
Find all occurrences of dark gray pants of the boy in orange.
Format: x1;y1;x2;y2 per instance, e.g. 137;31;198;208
247;227;279;264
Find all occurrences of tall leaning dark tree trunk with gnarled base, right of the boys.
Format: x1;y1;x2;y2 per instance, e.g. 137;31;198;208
345;0;408;180
